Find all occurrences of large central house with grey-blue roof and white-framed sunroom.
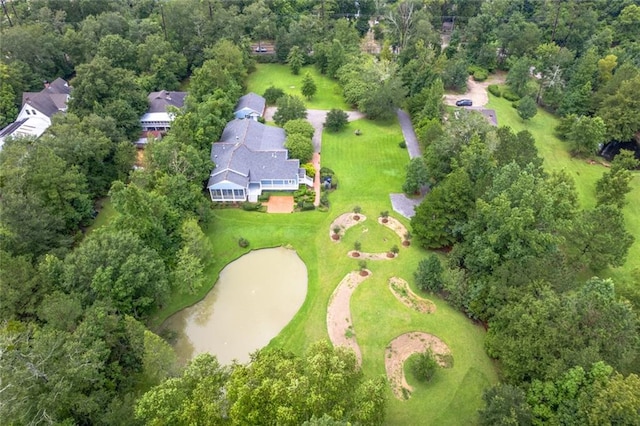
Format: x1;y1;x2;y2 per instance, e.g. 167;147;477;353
207;119;313;202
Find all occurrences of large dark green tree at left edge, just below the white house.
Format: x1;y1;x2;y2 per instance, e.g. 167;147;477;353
0;139;92;256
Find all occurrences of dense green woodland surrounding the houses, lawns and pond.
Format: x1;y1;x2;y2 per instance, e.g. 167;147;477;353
0;0;640;425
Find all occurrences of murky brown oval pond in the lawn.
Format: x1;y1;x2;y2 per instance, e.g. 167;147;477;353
162;247;307;364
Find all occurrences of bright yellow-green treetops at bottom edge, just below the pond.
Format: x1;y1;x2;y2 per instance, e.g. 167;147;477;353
227;342;386;424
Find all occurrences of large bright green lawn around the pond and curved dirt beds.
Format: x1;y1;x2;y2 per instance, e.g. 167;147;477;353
153;114;497;425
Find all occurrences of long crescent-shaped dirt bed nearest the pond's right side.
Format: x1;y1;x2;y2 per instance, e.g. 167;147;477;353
327;271;371;365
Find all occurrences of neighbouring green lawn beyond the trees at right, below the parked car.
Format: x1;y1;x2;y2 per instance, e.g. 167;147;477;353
487;94;640;300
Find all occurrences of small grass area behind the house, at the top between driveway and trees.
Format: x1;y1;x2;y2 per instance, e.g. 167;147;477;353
247;64;350;110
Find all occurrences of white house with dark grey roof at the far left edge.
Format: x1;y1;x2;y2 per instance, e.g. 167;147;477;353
0;78;71;149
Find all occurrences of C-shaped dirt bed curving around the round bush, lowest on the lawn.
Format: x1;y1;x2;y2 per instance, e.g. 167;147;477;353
384;331;451;399
